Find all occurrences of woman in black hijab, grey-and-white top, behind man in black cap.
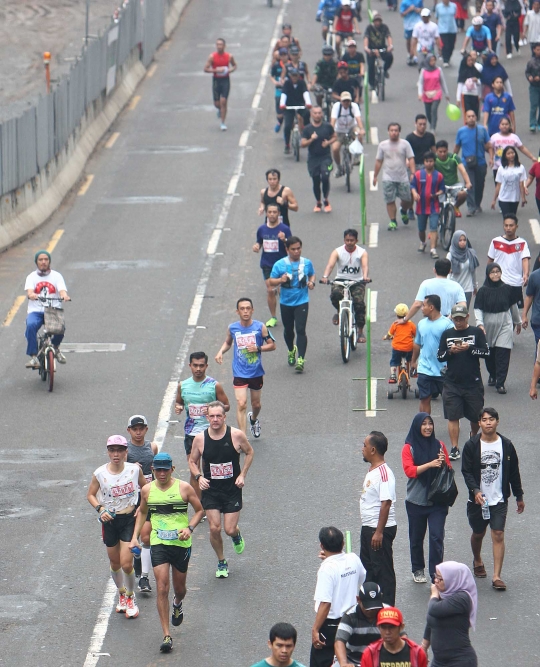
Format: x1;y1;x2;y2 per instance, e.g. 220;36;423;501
474;262;521;394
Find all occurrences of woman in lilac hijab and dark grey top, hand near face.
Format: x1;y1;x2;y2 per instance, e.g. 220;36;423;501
422;560;478;667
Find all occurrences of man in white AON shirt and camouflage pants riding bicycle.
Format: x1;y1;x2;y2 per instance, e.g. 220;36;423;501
321;229;369;343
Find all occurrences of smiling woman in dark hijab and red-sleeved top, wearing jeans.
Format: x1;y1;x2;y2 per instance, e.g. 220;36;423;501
401;412;452;584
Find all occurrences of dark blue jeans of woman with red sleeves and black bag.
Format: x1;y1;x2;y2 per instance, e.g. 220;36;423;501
405;501;448;579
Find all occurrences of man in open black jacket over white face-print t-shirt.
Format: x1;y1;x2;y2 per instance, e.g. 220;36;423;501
461;408;525;591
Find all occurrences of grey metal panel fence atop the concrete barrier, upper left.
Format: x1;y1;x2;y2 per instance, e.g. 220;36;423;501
0;0;168;195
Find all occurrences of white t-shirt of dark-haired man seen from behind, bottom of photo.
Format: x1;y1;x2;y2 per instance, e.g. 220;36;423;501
313;552;366;619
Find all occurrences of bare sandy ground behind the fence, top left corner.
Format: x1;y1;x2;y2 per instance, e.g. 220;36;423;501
0;0;122;121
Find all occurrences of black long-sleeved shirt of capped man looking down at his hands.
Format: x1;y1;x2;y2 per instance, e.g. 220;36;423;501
437;326;489;387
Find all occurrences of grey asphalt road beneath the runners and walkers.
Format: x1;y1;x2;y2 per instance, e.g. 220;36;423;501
0;0;540;667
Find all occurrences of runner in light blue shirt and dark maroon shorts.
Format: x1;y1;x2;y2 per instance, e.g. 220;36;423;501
216;298;276;438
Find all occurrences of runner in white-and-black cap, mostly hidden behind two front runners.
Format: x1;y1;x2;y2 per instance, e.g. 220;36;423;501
127;415;158;593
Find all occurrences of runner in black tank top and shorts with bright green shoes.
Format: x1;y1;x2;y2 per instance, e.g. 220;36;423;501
189;401;253;577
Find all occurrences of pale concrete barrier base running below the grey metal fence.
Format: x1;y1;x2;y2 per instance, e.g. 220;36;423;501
0;0;190;252
